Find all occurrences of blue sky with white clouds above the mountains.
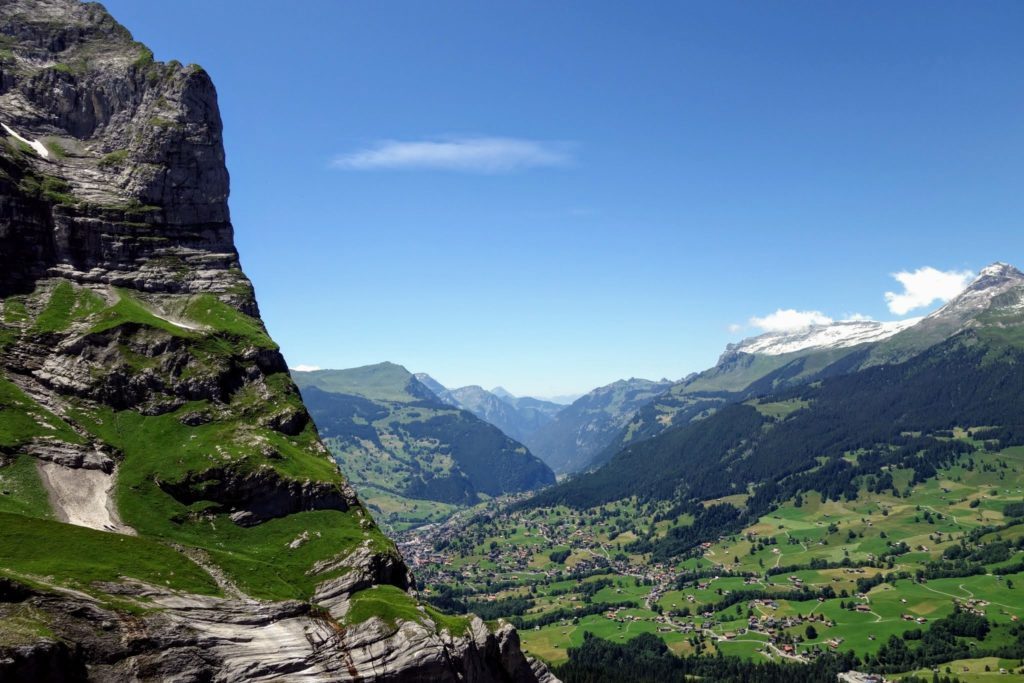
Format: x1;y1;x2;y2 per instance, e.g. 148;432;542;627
105;0;1024;395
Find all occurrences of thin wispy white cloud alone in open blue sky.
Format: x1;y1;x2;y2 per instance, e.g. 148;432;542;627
331;137;572;173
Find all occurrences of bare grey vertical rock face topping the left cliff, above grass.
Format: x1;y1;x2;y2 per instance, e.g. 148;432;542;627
0;0;237;299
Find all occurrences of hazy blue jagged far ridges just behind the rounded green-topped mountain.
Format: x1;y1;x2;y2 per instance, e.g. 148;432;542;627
416;373;565;445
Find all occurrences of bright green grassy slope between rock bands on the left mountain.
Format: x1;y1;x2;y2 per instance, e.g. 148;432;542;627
0;280;393;599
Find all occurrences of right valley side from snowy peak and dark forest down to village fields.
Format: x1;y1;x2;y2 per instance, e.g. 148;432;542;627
315;264;1024;681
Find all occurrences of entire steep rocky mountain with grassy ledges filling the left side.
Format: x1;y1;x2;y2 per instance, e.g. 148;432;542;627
0;0;548;681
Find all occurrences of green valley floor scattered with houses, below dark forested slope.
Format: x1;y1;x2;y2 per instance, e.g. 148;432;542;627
399;440;1024;681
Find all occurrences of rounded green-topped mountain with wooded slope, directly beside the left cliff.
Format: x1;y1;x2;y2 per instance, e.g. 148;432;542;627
292;362;555;514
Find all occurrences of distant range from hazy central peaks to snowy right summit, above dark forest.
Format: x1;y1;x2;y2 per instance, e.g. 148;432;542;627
309;263;1022;491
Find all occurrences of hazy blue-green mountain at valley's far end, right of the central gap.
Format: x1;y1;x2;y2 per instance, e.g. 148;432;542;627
529;379;672;473
